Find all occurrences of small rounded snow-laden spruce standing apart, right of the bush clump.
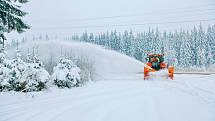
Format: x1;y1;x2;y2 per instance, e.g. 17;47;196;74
52;58;81;88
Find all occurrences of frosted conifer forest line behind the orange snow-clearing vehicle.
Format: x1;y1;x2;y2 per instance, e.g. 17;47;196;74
72;24;215;68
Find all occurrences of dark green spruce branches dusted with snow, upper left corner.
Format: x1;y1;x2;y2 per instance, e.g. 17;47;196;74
0;0;30;47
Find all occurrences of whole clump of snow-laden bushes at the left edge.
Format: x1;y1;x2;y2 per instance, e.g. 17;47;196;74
0;49;50;92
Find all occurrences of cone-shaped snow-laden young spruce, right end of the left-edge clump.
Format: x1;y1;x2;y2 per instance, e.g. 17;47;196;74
17;56;50;92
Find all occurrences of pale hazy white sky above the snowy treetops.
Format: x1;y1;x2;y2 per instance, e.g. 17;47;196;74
7;0;215;36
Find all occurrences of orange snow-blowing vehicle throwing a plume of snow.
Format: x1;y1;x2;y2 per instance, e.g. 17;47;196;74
144;54;174;80
